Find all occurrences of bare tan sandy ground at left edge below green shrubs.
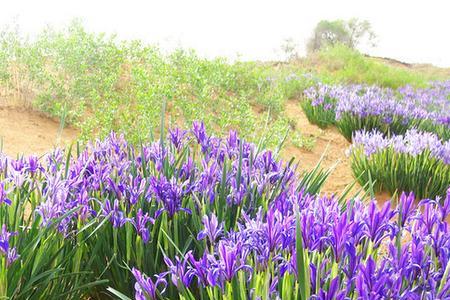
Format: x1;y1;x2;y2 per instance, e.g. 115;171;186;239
0;104;78;157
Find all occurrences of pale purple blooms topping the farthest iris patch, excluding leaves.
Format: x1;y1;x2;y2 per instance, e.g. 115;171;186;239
305;81;450;127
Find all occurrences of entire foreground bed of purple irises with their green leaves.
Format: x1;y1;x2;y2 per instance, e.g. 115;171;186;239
0;122;450;300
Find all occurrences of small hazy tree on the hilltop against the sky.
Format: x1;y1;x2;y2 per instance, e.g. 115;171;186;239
307;18;376;52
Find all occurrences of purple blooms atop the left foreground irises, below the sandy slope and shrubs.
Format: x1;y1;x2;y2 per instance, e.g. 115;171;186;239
4;122;295;242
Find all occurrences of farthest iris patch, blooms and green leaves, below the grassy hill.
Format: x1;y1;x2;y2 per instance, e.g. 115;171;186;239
302;81;450;140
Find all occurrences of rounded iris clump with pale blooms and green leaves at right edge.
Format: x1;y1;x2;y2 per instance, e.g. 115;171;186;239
350;129;450;198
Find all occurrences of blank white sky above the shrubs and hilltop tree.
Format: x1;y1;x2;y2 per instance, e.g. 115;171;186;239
0;0;450;67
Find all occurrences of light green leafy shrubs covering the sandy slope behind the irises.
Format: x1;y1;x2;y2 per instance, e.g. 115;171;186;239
0;21;320;146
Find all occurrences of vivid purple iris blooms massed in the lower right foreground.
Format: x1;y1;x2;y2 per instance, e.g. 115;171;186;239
136;190;450;299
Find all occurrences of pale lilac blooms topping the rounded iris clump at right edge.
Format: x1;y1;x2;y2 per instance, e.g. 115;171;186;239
352;129;450;165
